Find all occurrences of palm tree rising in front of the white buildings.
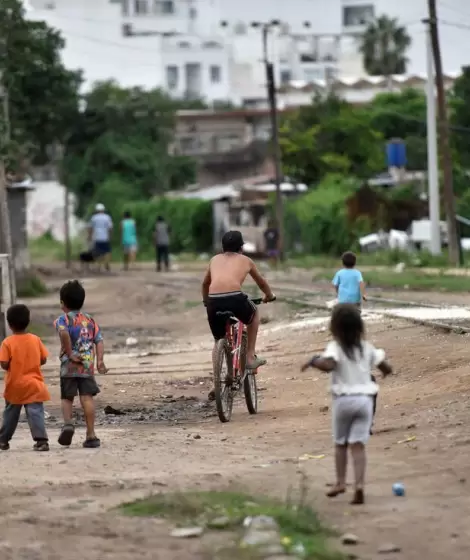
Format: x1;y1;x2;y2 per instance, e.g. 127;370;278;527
359;16;411;76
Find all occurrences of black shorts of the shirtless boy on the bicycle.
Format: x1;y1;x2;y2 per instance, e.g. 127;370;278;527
207;292;256;340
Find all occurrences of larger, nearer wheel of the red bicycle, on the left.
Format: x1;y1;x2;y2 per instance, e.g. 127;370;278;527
213;338;233;422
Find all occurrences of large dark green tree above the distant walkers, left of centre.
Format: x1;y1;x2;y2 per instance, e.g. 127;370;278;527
62;81;196;214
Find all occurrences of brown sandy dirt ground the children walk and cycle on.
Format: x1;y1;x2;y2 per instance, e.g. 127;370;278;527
0;270;470;560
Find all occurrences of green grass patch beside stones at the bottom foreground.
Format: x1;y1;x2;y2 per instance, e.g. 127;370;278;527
121;492;344;560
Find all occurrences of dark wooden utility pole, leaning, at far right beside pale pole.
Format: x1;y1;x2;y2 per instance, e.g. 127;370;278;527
428;0;461;266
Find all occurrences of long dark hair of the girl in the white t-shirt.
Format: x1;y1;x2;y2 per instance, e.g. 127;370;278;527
330;303;365;360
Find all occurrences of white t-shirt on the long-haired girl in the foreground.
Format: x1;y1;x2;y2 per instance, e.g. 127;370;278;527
323;340;385;397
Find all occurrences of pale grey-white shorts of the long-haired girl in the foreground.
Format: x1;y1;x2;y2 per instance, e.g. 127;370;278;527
333;395;374;445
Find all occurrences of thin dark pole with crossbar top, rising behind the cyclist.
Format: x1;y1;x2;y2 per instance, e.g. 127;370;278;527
255;22;284;261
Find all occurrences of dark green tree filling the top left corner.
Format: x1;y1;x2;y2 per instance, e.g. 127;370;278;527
0;0;81;163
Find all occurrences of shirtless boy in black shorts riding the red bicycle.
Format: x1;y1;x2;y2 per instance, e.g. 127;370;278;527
202;231;276;371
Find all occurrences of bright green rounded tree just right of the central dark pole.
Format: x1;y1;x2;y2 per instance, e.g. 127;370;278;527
281;97;385;185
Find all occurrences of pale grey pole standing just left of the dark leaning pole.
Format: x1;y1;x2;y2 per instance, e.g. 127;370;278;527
423;20;441;255
